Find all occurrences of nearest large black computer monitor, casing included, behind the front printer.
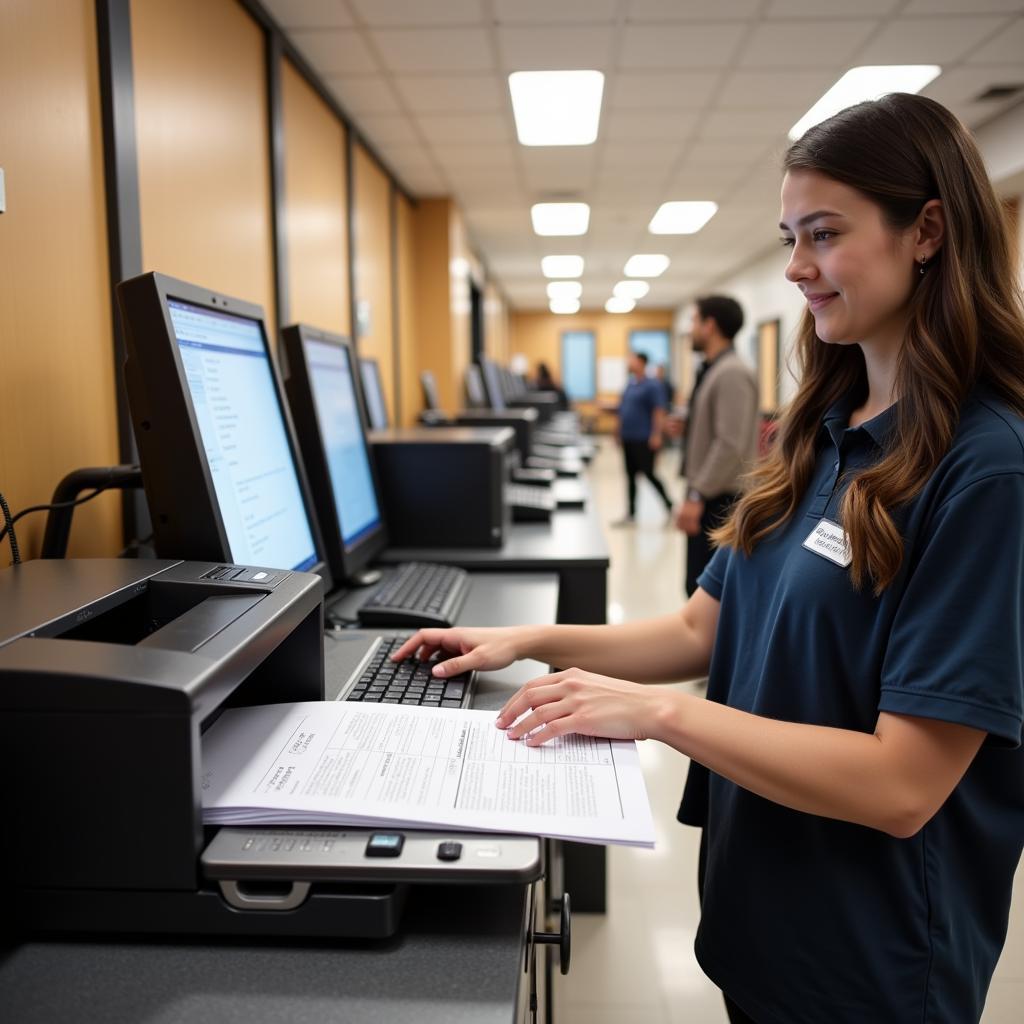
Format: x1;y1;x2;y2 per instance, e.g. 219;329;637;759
117;273;330;585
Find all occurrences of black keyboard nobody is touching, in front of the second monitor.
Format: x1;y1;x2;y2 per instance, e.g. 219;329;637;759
358;562;469;626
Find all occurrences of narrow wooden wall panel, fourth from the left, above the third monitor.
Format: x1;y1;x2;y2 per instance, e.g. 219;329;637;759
351;144;395;422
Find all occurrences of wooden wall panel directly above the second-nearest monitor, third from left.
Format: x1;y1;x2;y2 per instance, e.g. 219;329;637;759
282;60;351;335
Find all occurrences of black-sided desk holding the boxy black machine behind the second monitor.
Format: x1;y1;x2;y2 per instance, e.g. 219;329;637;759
380;481;609;626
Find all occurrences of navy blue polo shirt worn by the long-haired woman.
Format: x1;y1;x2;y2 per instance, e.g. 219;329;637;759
680;391;1024;1024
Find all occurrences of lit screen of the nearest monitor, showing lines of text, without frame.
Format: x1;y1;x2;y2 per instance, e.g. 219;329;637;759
167;298;319;570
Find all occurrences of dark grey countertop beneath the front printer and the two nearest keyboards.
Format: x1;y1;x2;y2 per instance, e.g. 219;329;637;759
0;573;558;1024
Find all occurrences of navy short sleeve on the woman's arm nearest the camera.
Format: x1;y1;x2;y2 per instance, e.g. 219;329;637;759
876;473;1024;746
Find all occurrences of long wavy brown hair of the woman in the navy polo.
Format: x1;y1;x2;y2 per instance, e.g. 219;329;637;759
712;93;1024;594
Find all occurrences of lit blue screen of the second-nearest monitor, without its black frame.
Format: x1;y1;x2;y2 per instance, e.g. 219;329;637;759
303;338;381;551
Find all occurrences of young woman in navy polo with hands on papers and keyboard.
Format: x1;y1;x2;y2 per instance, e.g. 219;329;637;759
398;94;1024;1024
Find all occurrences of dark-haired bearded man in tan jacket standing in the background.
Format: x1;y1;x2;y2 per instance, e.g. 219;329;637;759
676;295;758;597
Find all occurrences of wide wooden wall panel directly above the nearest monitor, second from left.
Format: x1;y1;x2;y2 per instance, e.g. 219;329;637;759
131;0;274;324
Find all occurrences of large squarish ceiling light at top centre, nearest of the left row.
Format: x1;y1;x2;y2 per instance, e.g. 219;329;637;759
509;71;604;145
